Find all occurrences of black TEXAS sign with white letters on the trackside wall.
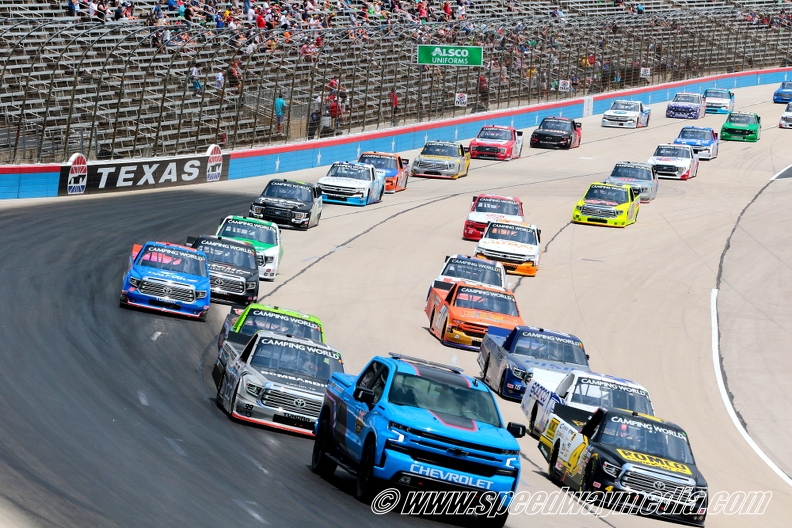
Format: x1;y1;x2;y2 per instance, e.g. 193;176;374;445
58;145;229;196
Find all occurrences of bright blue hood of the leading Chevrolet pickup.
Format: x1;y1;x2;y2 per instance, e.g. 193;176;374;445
390;405;520;451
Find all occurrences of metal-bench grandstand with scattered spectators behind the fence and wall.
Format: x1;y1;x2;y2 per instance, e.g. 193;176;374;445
0;0;792;163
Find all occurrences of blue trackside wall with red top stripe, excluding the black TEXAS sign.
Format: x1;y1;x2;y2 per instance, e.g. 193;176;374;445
0;68;792;198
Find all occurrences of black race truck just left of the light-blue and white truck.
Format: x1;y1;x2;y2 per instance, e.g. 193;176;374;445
248;179;322;229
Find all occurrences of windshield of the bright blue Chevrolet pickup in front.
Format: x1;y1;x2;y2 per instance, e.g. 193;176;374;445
388;372;503;427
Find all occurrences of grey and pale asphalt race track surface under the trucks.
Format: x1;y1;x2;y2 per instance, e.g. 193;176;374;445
0;86;792;528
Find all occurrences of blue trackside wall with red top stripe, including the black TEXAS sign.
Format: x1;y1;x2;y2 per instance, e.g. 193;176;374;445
0;68;792;198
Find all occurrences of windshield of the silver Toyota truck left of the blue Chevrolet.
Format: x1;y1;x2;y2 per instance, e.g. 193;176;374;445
250;337;344;380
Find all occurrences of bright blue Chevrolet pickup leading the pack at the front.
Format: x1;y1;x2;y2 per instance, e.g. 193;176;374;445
311;354;525;527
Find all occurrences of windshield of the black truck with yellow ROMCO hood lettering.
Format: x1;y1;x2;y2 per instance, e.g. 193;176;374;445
599;416;694;464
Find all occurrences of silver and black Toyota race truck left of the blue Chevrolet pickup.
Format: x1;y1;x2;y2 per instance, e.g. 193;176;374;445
212;330;344;436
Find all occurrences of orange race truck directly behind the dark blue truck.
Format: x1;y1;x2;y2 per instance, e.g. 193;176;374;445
424;282;525;350
